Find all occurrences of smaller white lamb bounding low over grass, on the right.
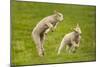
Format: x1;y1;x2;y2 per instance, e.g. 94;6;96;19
57;24;81;55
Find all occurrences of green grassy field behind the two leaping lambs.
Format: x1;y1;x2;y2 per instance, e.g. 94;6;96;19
11;0;96;65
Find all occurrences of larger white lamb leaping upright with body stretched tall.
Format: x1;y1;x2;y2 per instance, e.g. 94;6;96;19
32;11;63;57
